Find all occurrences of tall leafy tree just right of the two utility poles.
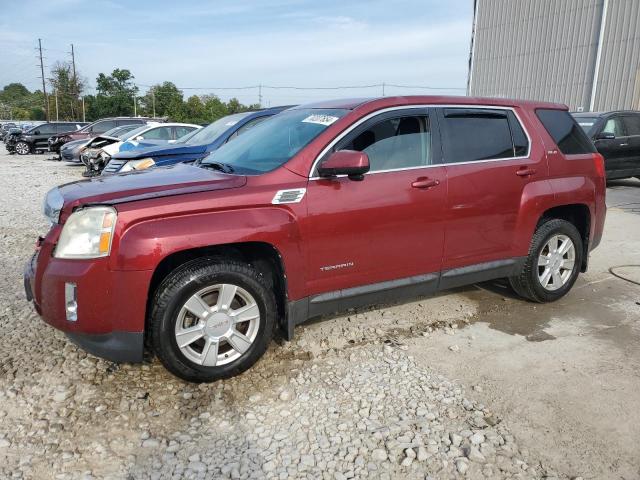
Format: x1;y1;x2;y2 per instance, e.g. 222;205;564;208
92;68;138;118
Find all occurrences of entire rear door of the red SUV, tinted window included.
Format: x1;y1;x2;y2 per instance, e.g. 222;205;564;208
438;107;547;274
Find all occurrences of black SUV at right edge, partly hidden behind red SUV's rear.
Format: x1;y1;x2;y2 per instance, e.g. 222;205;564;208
572;111;640;180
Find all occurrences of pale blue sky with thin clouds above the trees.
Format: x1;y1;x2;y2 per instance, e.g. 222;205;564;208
0;0;473;105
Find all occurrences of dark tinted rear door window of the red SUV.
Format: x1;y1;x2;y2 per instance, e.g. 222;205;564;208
443;108;529;163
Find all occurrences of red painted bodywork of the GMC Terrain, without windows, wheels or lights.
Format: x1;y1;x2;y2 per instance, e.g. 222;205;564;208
25;97;605;348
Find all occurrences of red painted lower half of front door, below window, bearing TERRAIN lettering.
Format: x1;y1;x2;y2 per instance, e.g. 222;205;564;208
302;167;446;296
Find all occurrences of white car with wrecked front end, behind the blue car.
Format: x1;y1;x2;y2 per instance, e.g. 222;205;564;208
80;123;202;177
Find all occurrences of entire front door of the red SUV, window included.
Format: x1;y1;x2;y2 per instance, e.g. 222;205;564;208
303;108;447;295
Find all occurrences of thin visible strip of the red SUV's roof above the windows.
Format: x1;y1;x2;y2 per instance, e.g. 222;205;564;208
296;95;567;110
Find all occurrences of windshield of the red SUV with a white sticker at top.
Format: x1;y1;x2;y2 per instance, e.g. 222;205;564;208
202;108;348;175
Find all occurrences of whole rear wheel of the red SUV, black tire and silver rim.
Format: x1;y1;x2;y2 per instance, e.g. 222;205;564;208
509;219;583;303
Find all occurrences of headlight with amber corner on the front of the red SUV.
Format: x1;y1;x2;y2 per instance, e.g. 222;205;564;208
54;207;117;258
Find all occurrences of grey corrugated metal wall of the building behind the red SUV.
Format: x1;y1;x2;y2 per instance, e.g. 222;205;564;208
469;0;640;110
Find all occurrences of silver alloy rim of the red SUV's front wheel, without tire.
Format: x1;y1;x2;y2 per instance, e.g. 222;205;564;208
175;283;261;367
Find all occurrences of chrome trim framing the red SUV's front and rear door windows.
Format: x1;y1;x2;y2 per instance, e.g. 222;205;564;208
308;104;531;180
